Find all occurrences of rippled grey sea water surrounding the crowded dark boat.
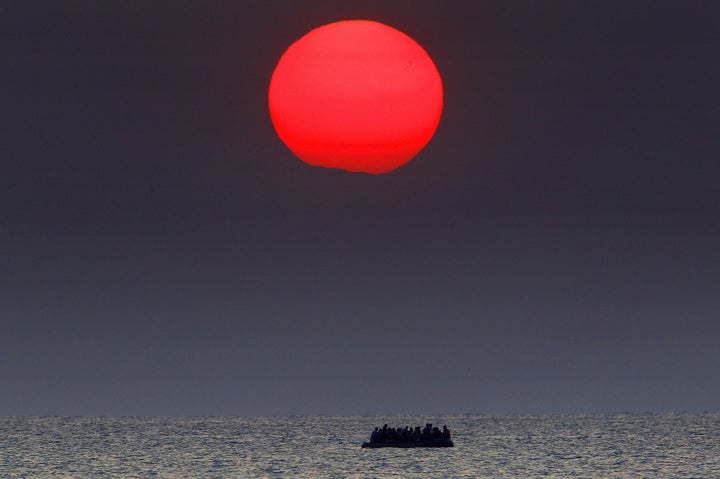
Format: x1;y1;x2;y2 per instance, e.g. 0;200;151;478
0;414;720;479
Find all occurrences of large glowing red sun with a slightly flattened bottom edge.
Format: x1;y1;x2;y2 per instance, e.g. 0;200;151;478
268;20;443;174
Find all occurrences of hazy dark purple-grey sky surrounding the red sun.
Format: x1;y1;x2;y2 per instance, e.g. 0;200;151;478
0;0;720;415
